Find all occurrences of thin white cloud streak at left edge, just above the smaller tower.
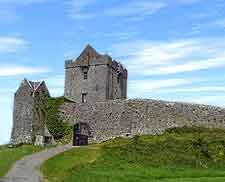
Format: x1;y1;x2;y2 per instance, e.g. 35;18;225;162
0;66;48;76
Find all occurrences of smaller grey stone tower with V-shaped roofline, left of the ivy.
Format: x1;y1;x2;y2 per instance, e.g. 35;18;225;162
11;79;52;145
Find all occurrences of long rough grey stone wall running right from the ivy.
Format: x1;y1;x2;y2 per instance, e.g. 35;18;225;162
60;100;225;143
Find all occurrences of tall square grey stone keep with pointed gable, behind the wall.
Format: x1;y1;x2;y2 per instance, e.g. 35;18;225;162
64;45;127;103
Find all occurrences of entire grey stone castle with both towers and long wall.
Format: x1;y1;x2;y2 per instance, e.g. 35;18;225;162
11;45;225;145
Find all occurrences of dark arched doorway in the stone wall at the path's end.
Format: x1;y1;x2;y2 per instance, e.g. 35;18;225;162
73;123;90;146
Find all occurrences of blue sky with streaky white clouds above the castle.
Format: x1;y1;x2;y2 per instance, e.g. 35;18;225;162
0;0;225;143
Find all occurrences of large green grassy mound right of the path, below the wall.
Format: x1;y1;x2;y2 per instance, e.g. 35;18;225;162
41;127;225;182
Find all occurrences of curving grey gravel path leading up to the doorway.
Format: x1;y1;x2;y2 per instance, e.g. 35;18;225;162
3;144;72;182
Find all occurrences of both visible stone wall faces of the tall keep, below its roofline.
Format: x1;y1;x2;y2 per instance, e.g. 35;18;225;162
64;62;127;103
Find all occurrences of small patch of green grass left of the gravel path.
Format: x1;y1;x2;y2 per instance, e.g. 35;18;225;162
0;145;42;177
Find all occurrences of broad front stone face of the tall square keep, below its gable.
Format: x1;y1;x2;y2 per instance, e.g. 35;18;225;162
65;65;108;103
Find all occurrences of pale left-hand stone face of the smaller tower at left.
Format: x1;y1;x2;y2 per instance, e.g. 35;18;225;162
11;84;34;144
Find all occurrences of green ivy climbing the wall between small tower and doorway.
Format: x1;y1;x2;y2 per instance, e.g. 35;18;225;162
46;97;71;140
